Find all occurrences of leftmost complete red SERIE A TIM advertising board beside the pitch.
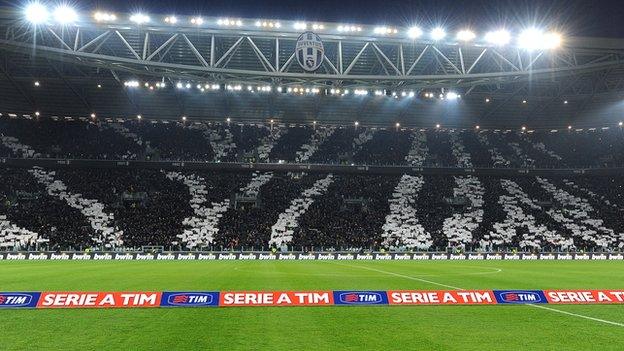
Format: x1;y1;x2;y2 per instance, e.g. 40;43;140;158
37;292;162;308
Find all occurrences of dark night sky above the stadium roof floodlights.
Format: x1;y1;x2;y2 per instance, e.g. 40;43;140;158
37;0;624;38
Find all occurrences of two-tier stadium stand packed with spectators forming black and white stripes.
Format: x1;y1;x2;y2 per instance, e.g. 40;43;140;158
0;117;624;251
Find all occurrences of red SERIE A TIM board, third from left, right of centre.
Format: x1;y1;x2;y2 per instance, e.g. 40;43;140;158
388;290;496;305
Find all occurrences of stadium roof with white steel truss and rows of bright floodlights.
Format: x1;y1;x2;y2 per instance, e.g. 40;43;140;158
0;8;624;126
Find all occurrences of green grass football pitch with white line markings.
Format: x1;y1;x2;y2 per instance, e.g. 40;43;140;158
0;261;624;350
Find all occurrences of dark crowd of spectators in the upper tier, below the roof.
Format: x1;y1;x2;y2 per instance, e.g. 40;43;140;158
0;117;624;168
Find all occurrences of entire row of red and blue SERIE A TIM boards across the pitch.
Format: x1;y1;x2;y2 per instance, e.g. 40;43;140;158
0;290;624;310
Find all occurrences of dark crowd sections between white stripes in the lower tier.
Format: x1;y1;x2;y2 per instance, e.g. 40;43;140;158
0;168;624;250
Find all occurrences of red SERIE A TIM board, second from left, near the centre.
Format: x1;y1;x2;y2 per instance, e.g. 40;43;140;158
219;291;334;307
